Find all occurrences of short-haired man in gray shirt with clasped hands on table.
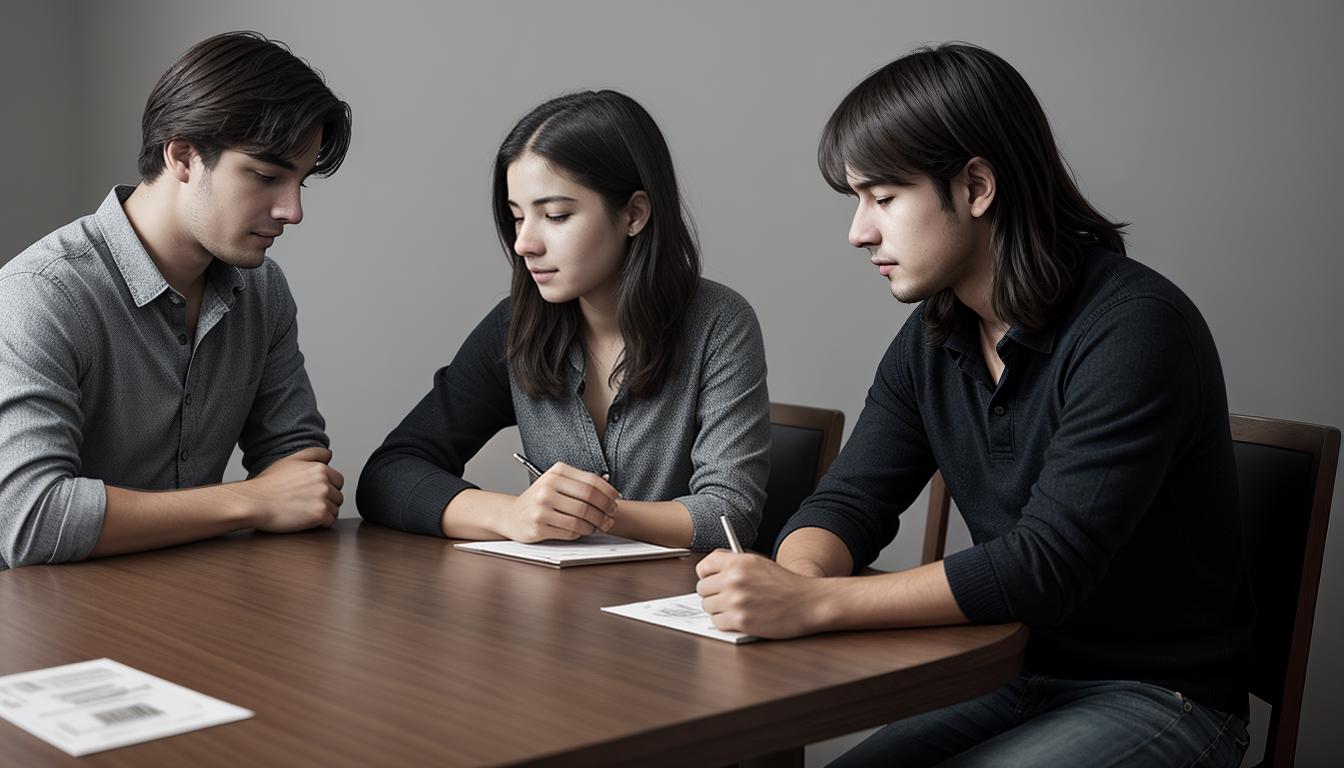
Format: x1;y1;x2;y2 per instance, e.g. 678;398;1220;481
0;32;351;569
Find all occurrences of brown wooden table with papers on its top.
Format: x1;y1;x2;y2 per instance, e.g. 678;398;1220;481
0;519;1027;768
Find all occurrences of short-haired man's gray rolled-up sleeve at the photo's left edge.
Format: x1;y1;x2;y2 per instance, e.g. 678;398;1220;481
0;272;108;568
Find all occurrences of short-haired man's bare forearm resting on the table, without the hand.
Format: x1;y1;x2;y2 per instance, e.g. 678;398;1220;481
91;483;253;557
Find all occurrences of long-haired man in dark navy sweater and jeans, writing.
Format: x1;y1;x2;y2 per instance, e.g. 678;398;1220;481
699;44;1253;765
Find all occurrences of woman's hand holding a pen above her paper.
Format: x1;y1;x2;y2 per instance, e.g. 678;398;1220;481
493;463;621;543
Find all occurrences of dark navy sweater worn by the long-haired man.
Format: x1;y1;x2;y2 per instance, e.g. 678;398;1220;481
780;249;1254;713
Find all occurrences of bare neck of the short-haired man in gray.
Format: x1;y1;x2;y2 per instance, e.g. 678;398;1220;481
121;180;214;296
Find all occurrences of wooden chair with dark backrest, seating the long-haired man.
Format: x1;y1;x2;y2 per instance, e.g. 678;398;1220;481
923;414;1340;767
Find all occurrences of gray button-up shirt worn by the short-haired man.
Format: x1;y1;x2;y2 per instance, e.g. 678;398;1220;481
0;187;328;569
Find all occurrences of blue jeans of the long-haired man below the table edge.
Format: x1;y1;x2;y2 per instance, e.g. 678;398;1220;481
829;674;1250;768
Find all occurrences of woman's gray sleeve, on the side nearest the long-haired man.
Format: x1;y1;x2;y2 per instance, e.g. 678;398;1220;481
675;307;770;551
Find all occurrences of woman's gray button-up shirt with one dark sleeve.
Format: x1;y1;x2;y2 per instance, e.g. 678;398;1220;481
356;280;770;550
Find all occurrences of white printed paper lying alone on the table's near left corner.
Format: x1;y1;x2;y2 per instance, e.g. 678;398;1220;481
0;659;253;757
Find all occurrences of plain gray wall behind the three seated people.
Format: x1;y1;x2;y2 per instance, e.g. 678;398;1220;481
0;0;1344;765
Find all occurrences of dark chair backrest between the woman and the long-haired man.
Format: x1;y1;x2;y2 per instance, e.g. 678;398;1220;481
751;402;844;555
